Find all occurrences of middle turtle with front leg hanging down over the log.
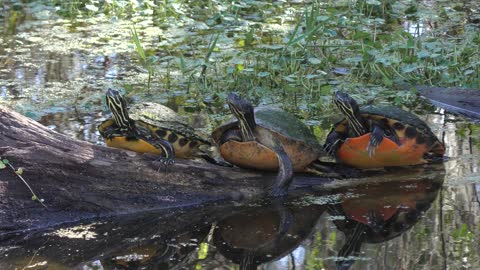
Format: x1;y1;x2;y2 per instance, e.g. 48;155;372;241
212;92;323;197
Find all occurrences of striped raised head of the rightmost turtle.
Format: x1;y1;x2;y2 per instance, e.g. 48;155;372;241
333;91;367;136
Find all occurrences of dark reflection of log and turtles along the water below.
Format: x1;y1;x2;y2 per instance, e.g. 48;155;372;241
0;164;445;269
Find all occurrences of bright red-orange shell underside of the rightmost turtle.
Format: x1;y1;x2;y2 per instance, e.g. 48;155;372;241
337;133;428;169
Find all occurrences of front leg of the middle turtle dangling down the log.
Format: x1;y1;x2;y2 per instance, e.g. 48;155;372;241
256;130;293;197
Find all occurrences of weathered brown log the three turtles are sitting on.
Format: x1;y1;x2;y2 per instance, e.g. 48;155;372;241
0;106;330;234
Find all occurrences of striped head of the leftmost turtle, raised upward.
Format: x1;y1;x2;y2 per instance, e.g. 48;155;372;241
105;88;135;131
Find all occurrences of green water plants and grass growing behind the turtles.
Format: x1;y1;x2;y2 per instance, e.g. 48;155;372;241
0;0;480;127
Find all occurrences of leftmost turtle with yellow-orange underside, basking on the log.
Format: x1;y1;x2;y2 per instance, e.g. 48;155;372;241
98;89;210;164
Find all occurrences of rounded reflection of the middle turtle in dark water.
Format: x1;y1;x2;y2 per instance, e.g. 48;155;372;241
212;200;326;269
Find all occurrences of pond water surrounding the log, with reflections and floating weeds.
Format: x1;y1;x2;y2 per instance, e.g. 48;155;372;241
0;1;480;269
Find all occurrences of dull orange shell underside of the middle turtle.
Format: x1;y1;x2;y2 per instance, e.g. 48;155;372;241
219;140;318;172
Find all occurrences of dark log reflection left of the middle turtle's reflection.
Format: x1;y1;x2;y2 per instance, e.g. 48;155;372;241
0;206;216;269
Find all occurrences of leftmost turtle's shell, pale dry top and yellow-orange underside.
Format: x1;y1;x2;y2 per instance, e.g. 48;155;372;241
98;102;210;157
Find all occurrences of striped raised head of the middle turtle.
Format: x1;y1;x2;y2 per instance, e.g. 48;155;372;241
227;92;257;141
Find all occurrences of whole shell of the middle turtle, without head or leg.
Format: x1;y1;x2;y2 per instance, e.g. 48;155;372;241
212;107;323;171
